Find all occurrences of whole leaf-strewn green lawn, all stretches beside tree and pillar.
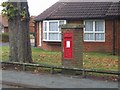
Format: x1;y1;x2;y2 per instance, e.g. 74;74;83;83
2;46;118;71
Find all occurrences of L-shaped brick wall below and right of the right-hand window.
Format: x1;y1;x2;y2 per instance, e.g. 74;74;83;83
83;20;113;52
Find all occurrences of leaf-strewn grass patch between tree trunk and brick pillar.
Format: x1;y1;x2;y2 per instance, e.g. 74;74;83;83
32;48;61;66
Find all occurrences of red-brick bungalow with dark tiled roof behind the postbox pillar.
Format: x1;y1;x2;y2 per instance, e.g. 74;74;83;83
34;0;120;54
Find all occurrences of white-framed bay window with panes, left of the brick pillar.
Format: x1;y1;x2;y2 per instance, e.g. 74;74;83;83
43;20;66;41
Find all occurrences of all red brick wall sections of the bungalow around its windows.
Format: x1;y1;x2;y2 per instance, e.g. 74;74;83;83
36;20;120;52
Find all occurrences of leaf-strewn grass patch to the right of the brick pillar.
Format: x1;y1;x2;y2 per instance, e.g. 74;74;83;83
84;52;118;70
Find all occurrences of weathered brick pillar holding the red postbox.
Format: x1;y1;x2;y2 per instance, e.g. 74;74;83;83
61;24;84;68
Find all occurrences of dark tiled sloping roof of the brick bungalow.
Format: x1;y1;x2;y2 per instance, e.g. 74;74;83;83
35;0;120;21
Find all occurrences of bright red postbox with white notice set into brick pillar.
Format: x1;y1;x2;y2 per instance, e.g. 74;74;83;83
64;33;73;59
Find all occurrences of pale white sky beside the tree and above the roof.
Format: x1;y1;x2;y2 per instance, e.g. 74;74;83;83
0;0;59;16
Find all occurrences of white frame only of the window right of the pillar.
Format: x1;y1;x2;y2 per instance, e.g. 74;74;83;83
83;20;105;42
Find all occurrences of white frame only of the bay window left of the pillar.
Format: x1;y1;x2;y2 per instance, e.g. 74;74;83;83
43;20;66;42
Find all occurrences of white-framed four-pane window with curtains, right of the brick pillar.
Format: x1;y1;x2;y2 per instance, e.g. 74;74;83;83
84;20;105;42
